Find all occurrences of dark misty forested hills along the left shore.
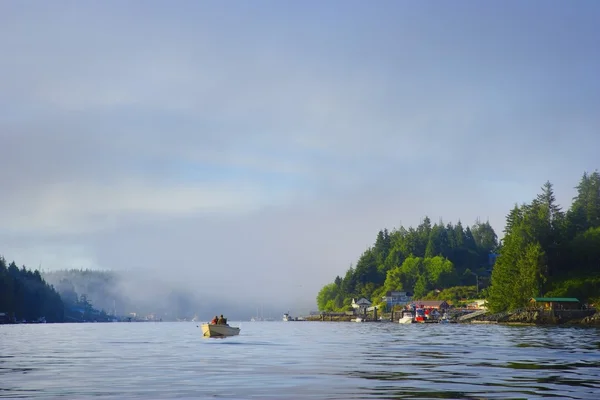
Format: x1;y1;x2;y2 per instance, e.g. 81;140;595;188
0;264;204;323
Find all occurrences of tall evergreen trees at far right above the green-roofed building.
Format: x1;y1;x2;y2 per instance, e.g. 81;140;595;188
488;172;600;311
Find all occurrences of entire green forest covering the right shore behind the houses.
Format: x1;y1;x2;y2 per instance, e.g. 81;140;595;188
317;171;600;312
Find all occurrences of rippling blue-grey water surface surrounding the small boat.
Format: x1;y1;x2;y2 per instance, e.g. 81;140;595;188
0;322;600;399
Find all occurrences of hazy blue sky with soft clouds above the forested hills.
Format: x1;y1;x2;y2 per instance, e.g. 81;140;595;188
0;0;600;317
